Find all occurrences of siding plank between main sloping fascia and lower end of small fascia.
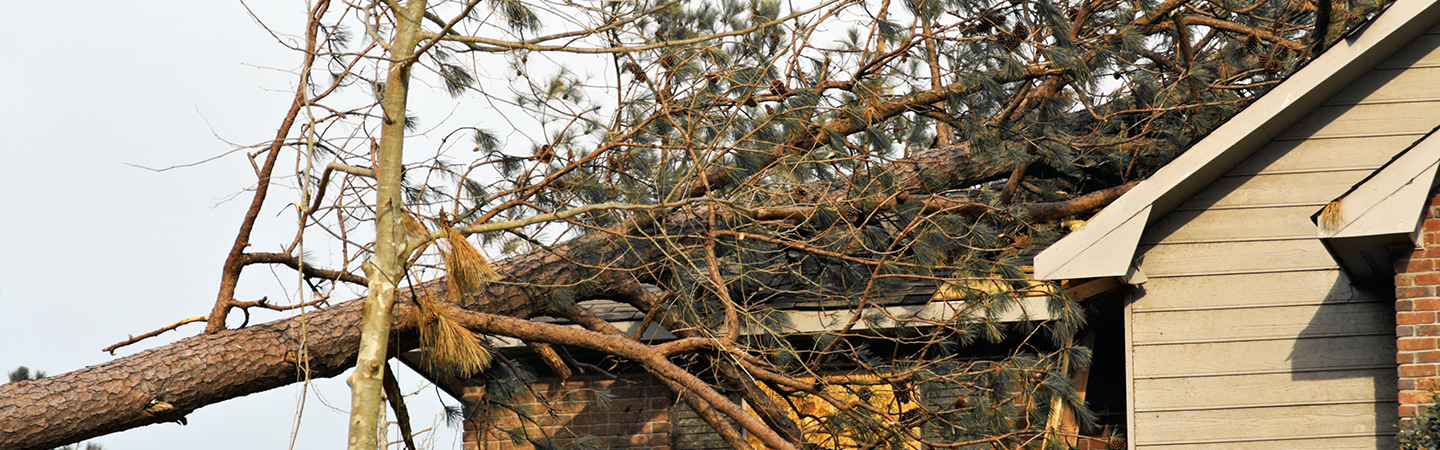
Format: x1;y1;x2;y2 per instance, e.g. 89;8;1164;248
1176;169;1374;211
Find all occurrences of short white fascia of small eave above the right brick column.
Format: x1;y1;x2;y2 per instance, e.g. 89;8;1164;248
1319;133;1440;239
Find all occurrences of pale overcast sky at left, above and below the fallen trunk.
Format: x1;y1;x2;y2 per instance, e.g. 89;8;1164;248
0;0;459;450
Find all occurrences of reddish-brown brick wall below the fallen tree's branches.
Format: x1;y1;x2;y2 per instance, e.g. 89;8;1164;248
464;375;672;450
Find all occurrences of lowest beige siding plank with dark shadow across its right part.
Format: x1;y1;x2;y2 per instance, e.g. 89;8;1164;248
1132;333;1395;381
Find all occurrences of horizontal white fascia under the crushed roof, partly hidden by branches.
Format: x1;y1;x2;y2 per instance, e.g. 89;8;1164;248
488;296;1051;348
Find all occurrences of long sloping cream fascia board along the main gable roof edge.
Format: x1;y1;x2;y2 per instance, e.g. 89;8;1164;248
1035;0;1440;280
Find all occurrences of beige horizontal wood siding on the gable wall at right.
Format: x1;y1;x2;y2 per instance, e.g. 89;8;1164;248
1126;25;1440;449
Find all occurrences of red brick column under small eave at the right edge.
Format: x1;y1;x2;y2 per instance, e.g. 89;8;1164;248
1395;195;1440;417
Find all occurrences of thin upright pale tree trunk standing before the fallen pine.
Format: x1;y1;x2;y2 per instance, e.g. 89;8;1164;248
348;0;425;450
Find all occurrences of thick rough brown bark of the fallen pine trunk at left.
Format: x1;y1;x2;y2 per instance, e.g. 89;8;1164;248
0;254;561;450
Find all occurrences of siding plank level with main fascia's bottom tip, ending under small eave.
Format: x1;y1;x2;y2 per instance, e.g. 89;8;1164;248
1139;239;1339;277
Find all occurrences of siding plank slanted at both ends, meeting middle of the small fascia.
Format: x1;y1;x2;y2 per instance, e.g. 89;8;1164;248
1230;133;1424;176
